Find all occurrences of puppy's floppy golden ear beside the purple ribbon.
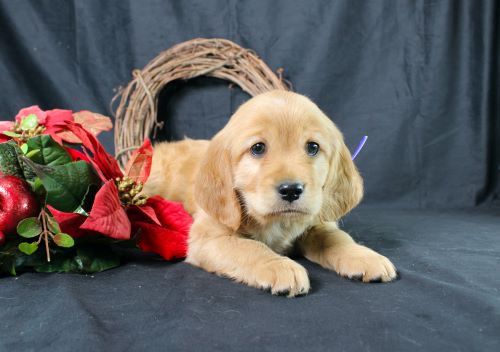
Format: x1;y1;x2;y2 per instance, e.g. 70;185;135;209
320;137;363;221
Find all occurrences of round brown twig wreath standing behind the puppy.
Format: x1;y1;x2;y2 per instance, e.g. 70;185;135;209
111;39;291;167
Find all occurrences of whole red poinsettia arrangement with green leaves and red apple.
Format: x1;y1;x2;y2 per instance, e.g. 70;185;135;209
0;106;192;275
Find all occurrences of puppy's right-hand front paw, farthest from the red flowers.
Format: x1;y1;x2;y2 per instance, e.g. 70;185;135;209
325;243;397;282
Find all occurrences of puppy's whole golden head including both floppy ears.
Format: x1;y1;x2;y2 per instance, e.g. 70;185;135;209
196;91;362;228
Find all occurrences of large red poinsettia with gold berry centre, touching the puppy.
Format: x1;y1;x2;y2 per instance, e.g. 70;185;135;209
51;122;192;260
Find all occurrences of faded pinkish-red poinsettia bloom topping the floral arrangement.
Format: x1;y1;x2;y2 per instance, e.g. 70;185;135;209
0;105;113;144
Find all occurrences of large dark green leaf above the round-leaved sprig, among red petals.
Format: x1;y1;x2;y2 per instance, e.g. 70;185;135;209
23;157;100;212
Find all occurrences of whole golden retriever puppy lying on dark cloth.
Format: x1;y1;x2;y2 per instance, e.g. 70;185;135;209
145;91;396;296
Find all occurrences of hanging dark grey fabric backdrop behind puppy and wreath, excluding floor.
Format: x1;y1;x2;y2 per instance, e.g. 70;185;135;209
0;0;500;208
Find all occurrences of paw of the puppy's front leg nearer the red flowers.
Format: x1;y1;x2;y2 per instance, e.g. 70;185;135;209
255;258;310;297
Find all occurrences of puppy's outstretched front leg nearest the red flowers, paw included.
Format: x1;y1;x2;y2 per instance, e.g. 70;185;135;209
186;221;310;297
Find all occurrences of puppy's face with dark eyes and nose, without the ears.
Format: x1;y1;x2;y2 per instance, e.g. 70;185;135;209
228;96;335;223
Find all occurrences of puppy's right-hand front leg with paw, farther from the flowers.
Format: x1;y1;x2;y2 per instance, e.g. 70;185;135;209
298;223;397;282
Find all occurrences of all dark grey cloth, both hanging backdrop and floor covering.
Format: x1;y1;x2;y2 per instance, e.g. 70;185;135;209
0;0;500;351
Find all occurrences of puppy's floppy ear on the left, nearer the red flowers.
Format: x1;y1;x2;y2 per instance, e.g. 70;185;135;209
194;135;241;231
